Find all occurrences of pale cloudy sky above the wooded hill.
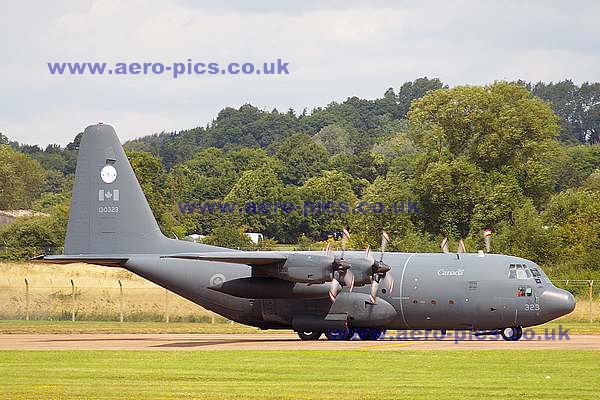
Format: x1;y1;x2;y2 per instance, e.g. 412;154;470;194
0;0;600;146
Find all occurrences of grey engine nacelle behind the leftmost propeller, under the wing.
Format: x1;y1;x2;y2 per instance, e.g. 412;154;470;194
261;254;333;283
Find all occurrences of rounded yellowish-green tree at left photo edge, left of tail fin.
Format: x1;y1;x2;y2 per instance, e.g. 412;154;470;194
0;145;45;210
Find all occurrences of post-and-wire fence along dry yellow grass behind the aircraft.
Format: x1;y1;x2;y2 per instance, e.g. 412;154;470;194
0;278;600;323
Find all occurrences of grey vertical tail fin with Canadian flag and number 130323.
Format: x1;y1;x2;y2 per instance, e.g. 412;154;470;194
65;124;166;255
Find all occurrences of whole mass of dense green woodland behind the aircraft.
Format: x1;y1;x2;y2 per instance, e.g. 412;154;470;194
0;78;600;277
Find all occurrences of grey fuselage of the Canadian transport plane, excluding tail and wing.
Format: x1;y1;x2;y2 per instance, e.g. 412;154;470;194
125;247;575;330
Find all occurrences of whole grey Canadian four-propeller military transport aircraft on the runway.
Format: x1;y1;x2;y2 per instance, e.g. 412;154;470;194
36;124;575;340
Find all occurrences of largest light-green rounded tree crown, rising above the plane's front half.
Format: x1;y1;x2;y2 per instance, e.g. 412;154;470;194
408;82;559;207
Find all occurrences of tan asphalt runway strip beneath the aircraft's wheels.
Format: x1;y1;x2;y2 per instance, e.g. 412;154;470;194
0;332;600;350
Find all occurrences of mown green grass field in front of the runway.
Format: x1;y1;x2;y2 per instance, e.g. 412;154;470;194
0;350;600;400
